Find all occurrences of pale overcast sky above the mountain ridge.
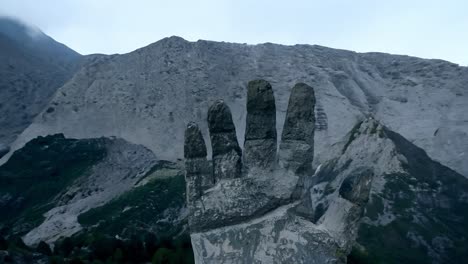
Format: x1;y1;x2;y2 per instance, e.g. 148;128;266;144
0;0;468;66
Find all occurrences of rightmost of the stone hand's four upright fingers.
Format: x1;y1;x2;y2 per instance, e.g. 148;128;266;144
279;83;315;174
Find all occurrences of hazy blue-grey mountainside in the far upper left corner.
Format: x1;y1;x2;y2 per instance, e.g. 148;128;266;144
0;17;81;156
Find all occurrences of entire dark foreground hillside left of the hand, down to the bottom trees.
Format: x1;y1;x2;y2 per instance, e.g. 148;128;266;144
0;134;193;263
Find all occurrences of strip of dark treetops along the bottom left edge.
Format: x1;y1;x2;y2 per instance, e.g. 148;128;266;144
0;233;194;264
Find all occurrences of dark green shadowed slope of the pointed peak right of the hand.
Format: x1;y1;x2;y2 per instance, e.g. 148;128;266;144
348;131;468;264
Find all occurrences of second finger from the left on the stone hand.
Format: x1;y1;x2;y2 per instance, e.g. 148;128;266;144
208;100;242;181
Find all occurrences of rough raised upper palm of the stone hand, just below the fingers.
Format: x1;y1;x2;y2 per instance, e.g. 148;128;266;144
186;171;299;232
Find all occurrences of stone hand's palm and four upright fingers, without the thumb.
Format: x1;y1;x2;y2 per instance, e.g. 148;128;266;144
184;80;364;263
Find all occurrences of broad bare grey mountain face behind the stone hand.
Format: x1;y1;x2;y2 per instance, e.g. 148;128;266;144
3;34;468;175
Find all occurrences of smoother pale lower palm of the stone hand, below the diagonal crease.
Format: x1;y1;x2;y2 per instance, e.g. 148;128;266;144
191;204;344;264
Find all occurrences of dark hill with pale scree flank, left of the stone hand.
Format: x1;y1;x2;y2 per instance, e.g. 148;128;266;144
0;135;166;245
